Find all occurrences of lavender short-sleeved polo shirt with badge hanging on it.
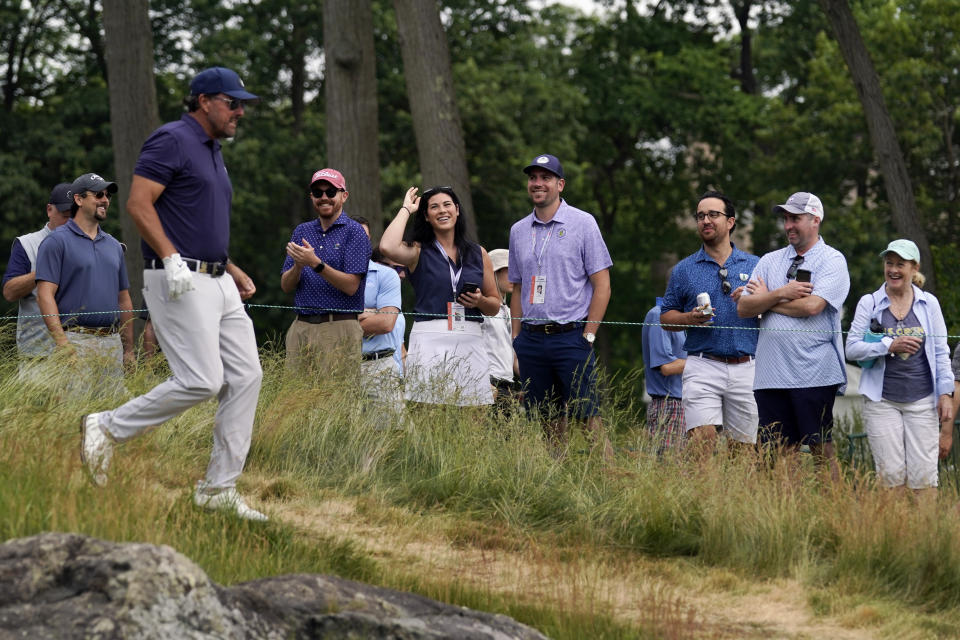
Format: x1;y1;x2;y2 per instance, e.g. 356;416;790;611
507;200;613;324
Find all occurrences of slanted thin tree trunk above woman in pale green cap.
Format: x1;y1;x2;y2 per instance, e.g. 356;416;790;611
819;0;937;292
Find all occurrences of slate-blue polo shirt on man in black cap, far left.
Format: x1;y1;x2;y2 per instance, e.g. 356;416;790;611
37;220;130;327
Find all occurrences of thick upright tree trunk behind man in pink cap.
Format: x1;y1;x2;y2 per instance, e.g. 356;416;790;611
323;0;383;239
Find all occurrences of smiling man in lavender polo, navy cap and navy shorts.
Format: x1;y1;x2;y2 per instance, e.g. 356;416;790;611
507;154;613;459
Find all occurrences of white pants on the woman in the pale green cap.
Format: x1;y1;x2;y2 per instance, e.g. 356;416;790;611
863;395;940;489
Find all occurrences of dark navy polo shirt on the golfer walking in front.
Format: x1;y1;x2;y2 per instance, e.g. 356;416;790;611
133;113;233;262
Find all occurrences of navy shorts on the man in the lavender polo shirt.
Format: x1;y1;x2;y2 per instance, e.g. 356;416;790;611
513;329;600;420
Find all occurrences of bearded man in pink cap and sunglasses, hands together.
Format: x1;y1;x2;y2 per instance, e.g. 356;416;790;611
280;168;371;375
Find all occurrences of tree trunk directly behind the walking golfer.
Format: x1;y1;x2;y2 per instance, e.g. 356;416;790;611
103;0;160;320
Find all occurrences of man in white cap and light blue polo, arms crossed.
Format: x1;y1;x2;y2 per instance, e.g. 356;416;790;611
738;191;850;476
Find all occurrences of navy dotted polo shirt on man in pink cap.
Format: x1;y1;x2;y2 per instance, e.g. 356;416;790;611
281;211;371;316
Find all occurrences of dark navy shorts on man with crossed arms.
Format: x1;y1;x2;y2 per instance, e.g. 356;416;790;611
753;384;840;445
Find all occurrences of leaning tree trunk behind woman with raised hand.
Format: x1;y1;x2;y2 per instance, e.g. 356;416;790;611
393;0;477;239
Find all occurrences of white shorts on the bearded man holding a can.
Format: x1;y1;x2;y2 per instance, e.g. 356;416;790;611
683;356;760;444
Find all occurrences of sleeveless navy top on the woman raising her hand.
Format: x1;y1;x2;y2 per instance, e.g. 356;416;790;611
410;243;483;322
